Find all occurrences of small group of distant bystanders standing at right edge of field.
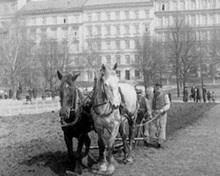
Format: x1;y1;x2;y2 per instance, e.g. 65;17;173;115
183;86;216;102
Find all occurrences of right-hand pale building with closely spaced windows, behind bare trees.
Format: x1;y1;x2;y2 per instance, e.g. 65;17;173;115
154;0;220;76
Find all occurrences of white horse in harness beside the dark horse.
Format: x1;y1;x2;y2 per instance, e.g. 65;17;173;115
91;64;137;175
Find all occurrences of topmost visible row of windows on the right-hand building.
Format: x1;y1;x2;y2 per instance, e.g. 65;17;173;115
156;0;220;11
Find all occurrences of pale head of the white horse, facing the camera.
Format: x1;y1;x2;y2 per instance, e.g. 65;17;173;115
97;63;121;107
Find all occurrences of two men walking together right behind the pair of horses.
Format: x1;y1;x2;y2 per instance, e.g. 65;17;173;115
136;83;170;148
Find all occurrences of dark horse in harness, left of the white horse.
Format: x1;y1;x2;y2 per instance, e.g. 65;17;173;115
57;71;93;174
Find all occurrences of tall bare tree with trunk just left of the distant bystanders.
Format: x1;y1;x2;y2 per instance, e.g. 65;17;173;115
165;16;198;97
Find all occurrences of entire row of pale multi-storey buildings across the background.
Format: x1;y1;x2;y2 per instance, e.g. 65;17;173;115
0;0;220;84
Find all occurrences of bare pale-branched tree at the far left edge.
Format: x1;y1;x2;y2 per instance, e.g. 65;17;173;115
0;21;36;99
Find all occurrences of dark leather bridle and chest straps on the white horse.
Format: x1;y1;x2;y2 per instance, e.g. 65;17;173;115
92;75;119;117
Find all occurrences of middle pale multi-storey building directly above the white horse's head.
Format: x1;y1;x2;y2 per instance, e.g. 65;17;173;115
83;0;153;81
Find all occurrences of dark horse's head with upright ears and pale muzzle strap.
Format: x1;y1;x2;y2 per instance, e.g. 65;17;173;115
57;71;80;125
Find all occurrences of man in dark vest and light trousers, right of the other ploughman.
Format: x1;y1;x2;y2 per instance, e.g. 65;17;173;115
152;83;170;148
